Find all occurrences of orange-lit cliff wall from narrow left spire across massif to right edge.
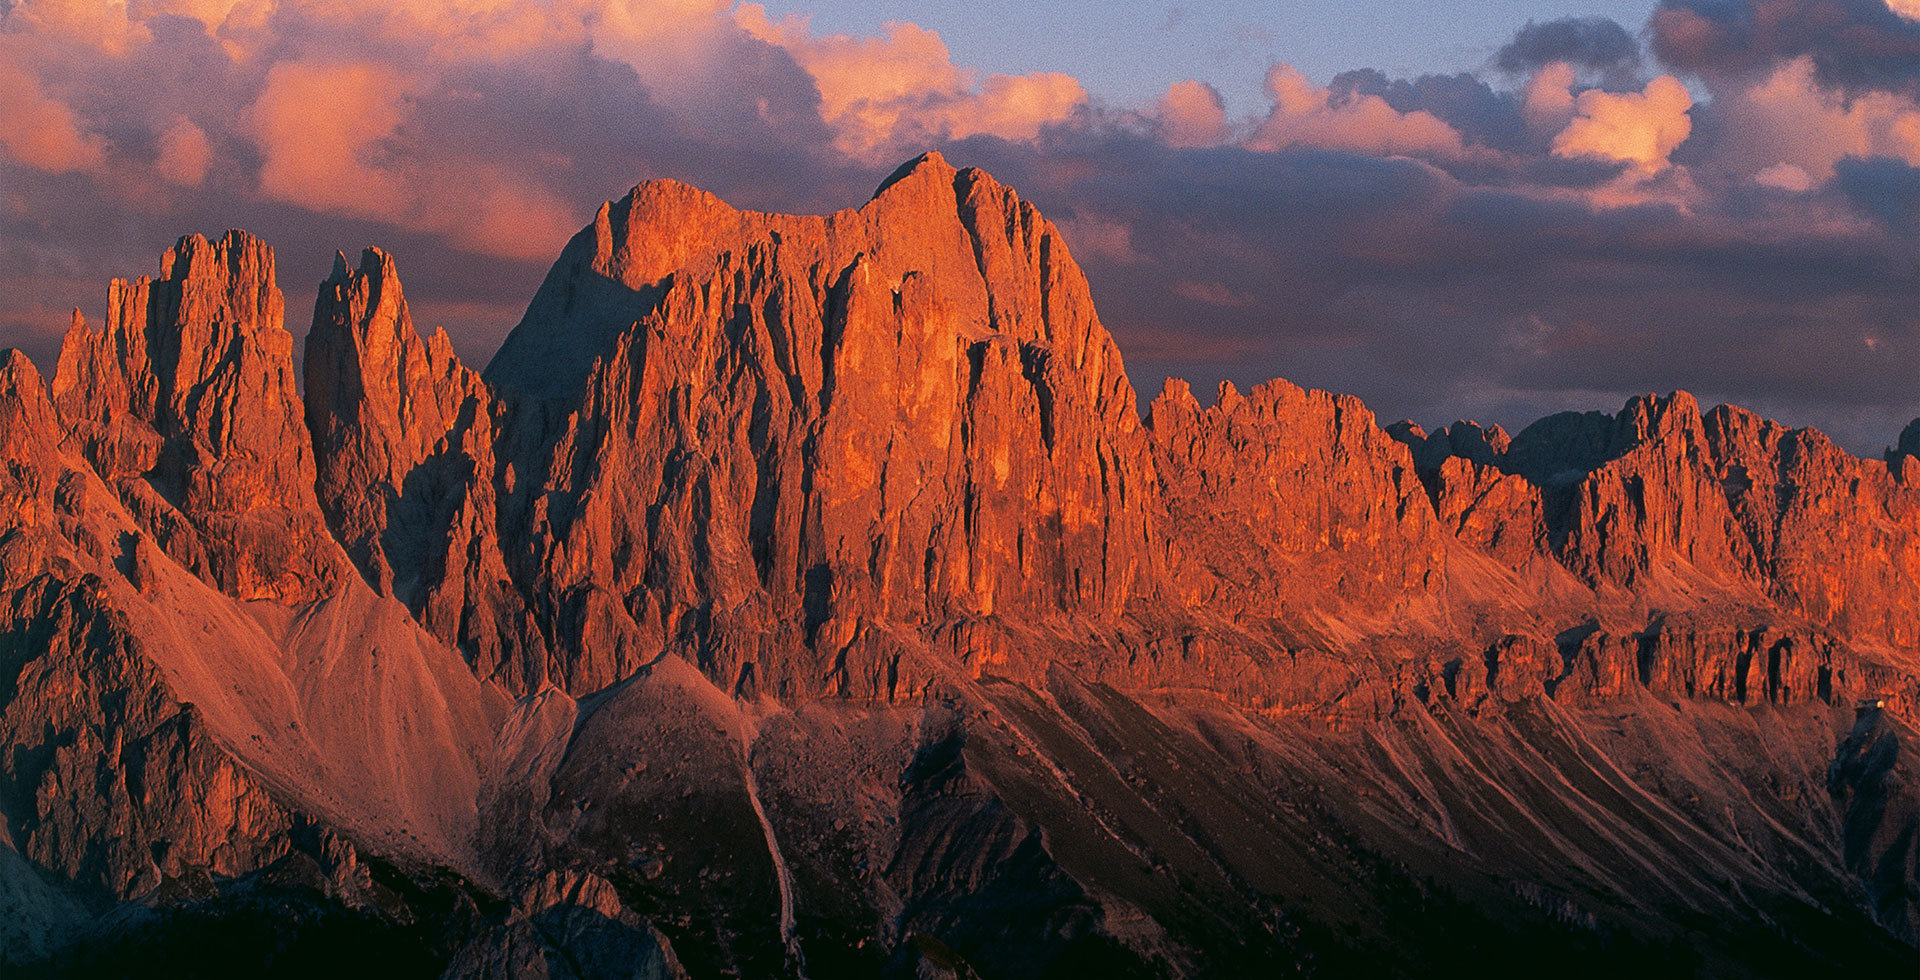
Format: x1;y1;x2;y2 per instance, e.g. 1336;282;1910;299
280;156;1912;715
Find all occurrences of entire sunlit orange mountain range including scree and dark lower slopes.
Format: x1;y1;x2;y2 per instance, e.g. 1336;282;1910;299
0;156;1920;978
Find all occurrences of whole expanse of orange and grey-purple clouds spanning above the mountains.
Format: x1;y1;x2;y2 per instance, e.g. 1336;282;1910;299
0;0;1920;455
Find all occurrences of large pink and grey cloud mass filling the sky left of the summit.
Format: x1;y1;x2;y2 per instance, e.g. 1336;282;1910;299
0;0;874;359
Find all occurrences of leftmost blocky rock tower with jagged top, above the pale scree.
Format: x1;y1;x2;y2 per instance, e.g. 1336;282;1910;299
54;231;338;603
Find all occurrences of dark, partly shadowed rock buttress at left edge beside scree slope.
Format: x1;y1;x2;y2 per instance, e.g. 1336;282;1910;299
0;352;290;901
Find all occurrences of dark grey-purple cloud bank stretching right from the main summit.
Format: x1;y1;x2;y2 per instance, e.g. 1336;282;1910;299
970;113;1920;452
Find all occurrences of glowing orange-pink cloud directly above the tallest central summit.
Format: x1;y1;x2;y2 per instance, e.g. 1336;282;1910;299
735;4;1087;159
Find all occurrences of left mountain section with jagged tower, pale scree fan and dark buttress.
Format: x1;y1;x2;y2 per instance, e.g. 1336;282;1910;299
0;233;503;968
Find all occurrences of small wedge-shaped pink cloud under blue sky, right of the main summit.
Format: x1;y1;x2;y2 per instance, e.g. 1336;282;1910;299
1246;65;1467;158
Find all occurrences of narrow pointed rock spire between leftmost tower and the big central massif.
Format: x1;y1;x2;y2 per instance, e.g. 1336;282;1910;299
305;248;545;692
